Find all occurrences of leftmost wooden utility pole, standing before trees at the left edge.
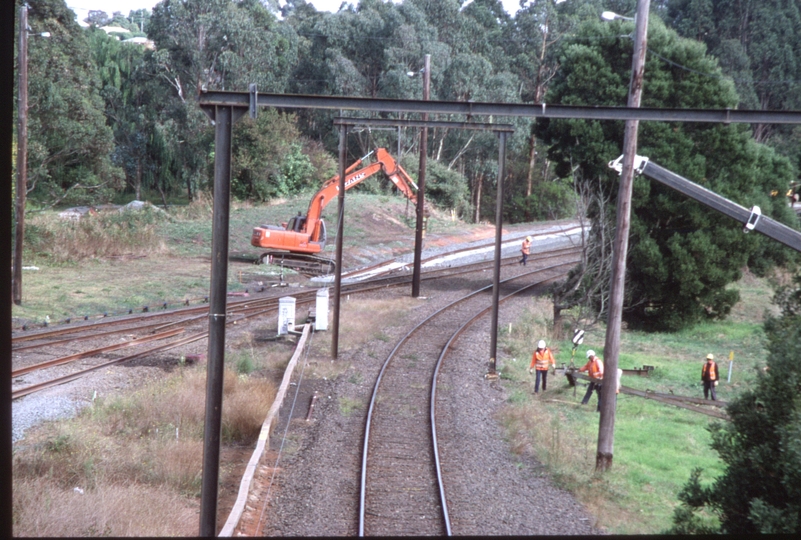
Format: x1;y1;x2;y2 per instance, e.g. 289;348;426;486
12;4;28;305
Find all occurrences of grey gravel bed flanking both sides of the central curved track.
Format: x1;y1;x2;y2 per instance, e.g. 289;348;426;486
255;264;600;536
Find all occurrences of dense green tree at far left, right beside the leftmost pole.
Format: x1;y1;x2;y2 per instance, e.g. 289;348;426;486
20;0;124;206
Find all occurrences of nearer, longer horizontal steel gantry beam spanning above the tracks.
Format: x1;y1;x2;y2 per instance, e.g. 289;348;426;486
198;91;801;124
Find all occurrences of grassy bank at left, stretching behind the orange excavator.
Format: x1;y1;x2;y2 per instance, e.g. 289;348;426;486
12;193;424;332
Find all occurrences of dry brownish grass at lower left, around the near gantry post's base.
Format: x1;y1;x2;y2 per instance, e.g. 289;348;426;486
13;367;276;536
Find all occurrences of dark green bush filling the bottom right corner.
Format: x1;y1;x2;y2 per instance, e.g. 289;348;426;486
671;274;801;534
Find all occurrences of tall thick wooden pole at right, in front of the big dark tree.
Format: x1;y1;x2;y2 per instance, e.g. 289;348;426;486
595;0;650;471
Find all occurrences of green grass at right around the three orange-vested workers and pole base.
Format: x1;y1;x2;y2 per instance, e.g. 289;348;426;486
499;276;772;534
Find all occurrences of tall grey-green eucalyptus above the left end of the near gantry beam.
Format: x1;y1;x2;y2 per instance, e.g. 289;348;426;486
148;0;297;198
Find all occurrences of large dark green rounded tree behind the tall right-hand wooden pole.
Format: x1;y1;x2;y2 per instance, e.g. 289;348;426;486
538;15;794;329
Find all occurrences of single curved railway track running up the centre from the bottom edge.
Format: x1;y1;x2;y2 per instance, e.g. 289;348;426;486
359;260;576;536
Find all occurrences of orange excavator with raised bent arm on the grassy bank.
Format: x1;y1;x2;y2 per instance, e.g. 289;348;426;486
250;148;417;275
